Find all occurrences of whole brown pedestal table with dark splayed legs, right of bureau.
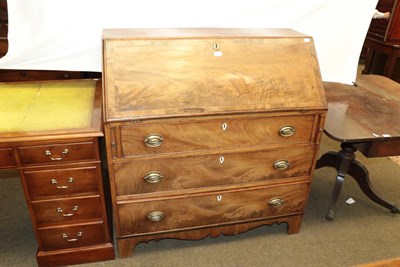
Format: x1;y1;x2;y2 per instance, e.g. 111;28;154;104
316;75;400;220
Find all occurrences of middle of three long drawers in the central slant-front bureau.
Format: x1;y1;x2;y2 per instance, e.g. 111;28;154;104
114;146;315;196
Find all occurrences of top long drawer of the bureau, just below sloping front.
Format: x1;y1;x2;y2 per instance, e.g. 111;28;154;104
117;115;315;156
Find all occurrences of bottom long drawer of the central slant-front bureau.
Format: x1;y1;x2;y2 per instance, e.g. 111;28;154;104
117;183;309;236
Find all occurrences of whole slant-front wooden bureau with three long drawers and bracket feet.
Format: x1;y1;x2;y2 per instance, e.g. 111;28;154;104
103;29;327;257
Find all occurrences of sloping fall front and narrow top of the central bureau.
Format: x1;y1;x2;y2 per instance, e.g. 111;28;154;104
103;28;326;122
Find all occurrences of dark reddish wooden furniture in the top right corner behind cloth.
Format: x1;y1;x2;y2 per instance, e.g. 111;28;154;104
363;0;400;80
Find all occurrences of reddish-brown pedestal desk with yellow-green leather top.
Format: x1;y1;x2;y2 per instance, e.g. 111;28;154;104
0;80;115;266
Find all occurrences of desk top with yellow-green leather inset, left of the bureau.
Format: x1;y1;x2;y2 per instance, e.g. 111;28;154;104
0;79;102;141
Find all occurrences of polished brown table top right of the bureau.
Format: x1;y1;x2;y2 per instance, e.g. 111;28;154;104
324;75;400;142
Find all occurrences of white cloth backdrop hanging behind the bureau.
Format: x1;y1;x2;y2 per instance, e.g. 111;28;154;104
0;0;378;84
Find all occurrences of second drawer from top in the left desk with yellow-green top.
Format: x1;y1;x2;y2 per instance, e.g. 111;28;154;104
23;164;101;200
